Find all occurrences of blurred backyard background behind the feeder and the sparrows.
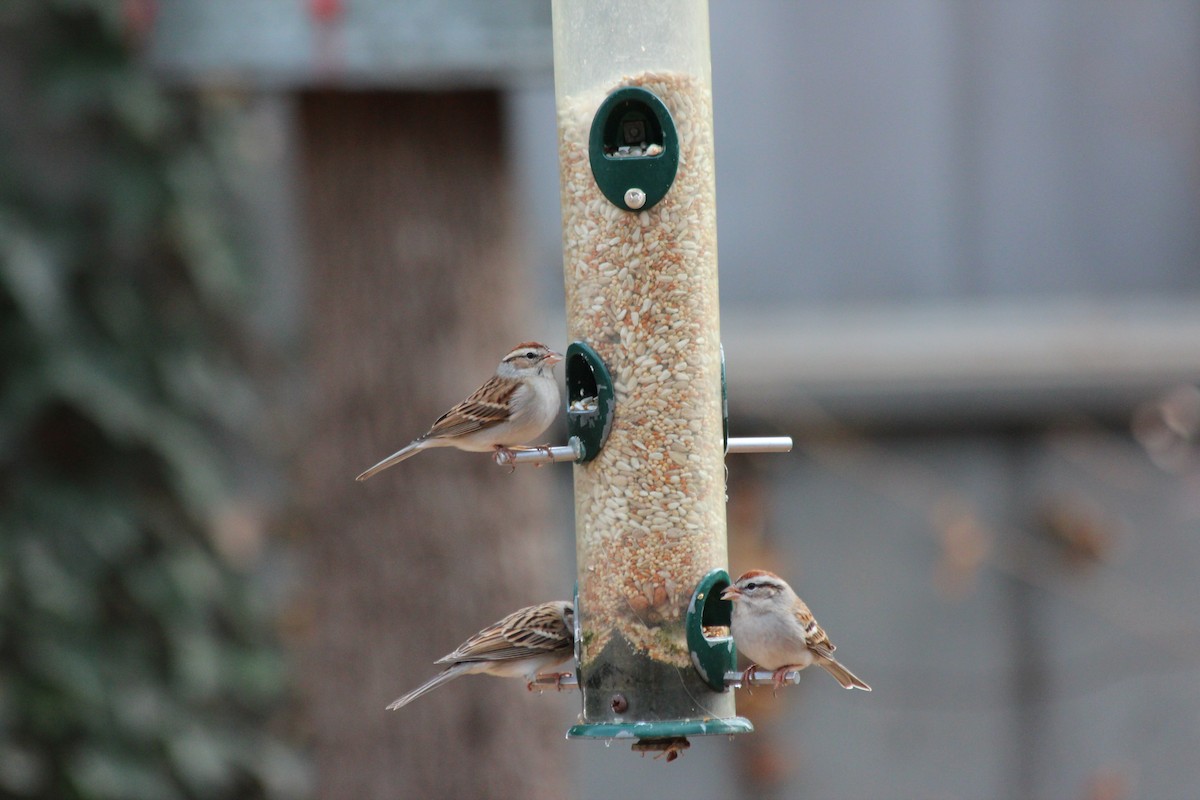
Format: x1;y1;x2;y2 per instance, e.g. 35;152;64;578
0;0;1200;800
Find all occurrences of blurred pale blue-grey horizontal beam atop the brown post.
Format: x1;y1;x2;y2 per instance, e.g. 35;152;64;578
149;0;552;89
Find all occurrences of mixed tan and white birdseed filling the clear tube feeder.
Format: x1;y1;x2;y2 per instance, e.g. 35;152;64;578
558;72;726;669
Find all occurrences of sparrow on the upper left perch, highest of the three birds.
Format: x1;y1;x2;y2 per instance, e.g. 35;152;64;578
355;342;563;481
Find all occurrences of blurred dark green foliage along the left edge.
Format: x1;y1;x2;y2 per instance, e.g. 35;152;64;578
0;0;306;800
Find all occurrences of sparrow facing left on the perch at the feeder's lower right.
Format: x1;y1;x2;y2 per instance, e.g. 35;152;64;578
721;570;871;692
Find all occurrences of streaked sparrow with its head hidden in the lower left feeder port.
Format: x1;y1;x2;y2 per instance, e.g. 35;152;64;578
388;600;575;711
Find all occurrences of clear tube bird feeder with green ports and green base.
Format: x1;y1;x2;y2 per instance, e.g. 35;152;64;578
552;0;752;758
